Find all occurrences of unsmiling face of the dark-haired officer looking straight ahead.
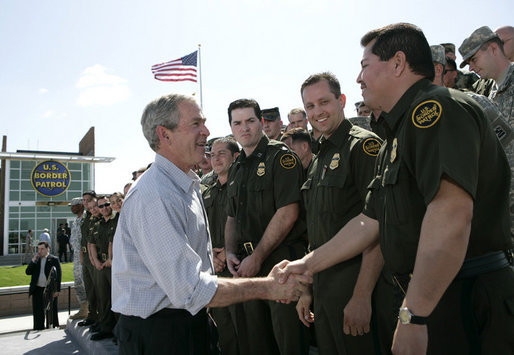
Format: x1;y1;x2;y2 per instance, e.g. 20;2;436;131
230;107;262;155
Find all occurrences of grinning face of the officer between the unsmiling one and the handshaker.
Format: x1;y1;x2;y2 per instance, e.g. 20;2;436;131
302;80;346;138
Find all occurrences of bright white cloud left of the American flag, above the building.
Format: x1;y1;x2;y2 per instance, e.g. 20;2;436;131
76;64;130;107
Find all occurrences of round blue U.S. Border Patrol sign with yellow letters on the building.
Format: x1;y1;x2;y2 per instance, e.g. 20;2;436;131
30;160;71;197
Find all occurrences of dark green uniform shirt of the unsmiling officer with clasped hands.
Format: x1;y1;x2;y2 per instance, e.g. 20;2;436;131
227;135;306;248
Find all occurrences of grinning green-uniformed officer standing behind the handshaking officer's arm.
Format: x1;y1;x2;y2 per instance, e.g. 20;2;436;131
299;73;383;354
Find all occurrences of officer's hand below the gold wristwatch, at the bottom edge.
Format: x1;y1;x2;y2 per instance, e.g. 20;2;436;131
391;321;428;355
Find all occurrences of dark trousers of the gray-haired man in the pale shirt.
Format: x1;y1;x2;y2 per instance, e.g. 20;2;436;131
114;309;219;355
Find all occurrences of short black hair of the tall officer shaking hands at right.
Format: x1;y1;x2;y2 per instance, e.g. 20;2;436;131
361;23;435;81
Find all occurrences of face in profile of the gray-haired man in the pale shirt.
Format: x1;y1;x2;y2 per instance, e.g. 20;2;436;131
164;101;210;173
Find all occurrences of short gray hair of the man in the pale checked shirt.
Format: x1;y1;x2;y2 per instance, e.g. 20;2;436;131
141;94;196;151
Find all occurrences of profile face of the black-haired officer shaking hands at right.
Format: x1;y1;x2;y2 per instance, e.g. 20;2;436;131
357;40;390;110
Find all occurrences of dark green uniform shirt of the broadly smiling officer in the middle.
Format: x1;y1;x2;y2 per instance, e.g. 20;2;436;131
302;120;382;249
